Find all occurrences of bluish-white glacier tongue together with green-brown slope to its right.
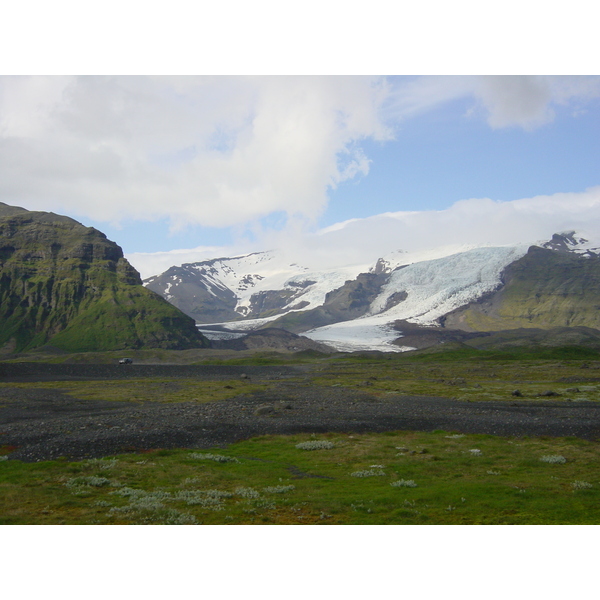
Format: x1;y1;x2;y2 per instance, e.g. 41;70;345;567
306;232;600;350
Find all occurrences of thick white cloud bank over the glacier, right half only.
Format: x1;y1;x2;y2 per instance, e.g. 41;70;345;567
306;186;600;260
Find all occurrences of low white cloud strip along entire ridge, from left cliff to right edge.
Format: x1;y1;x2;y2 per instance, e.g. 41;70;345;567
128;186;600;277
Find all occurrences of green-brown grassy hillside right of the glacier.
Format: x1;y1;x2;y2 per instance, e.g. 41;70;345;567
444;246;600;331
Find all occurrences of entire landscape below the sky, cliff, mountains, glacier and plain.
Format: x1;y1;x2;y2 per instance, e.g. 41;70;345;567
0;203;600;524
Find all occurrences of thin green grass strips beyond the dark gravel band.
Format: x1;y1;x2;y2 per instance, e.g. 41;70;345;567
0;348;600;402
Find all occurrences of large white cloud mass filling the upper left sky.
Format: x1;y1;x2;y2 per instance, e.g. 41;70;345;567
0;76;600;238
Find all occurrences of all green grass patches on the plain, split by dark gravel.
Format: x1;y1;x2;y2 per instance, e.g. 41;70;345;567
0;352;600;524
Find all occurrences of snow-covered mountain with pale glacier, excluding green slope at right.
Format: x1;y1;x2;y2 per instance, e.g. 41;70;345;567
145;232;600;351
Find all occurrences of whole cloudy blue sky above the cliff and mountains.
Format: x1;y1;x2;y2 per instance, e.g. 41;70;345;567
0;75;600;275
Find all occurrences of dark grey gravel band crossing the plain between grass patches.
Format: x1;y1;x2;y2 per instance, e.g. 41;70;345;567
0;363;600;462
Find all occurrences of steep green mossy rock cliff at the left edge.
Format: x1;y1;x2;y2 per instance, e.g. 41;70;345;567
0;203;209;352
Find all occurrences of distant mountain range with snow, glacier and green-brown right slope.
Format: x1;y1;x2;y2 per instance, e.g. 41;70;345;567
142;232;600;350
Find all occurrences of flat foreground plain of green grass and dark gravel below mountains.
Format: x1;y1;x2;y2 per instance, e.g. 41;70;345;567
0;348;600;524
